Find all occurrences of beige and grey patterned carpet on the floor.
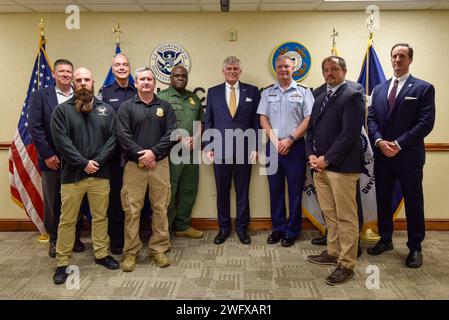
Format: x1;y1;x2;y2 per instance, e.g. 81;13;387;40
0;231;449;300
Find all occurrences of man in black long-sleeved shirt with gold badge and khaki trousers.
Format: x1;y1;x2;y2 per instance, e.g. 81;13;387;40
117;67;176;272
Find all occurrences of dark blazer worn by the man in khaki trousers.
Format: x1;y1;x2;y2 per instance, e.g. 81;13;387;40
306;83;365;173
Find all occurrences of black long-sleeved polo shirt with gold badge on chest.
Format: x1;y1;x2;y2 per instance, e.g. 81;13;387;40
117;94;177;162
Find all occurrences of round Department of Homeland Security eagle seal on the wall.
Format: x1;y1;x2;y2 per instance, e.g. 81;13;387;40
150;42;190;84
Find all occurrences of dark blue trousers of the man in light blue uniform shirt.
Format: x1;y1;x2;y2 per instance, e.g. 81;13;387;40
267;139;306;239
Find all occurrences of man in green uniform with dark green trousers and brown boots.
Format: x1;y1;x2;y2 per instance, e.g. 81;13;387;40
157;65;204;239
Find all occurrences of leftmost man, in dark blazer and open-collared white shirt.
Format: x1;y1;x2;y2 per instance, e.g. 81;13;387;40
28;59;85;258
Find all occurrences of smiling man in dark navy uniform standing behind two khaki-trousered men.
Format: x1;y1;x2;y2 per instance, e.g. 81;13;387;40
98;53;137;254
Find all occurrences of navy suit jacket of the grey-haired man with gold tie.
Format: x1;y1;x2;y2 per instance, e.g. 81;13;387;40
204;82;260;163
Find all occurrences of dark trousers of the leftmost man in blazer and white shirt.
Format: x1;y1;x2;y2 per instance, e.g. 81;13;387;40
42;171;83;242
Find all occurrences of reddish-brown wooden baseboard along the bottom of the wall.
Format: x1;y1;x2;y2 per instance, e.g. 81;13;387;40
0;218;449;232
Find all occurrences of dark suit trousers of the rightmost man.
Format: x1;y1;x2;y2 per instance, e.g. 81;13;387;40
374;158;425;250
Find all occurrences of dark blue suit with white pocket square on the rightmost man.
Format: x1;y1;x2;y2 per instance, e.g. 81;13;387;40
368;75;435;250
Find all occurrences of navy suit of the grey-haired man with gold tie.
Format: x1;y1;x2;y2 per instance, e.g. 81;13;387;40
204;82;260;233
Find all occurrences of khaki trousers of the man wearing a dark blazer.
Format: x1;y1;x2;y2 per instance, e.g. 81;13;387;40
313;170;360;270
